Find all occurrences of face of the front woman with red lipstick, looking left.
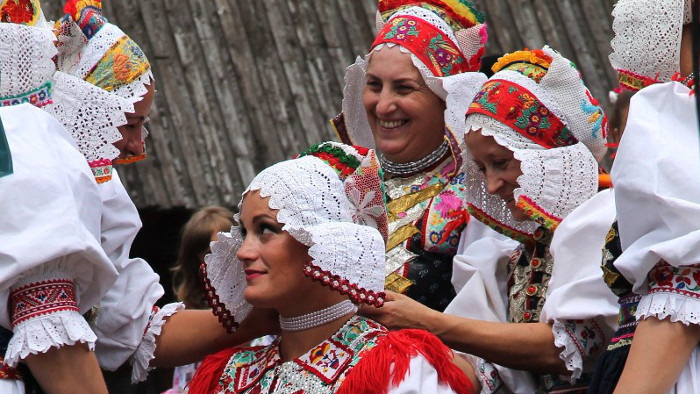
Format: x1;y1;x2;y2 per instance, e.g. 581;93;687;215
238;191;321;313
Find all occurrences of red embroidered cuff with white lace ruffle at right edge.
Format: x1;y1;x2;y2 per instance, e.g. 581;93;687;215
636;262;700;325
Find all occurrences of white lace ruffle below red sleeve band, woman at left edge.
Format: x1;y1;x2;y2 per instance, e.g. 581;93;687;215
5;310;97;367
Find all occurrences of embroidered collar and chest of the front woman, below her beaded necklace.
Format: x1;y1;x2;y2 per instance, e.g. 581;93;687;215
214;316;387;394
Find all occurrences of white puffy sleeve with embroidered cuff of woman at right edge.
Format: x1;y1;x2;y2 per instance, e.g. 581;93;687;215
612;82;700;324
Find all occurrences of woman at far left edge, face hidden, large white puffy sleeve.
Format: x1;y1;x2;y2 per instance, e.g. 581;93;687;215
0;5;128;393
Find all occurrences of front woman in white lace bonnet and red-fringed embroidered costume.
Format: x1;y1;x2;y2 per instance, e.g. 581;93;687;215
190;142;472;393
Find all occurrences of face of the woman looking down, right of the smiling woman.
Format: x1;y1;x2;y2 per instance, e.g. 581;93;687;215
464;130;529;222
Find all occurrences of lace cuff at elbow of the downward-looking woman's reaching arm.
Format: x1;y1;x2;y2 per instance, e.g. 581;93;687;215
552;319;606;384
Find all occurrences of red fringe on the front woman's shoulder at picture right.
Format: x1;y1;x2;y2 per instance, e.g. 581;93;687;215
338;330;474;394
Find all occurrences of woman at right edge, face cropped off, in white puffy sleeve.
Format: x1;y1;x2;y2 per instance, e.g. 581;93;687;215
590;0;700;393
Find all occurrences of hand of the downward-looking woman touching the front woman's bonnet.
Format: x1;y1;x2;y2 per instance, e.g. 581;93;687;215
358;291;439;332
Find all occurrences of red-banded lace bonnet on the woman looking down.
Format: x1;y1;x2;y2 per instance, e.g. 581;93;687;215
465;47;606;243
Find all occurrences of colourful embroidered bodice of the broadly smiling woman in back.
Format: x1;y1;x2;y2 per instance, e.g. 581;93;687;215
385;157;469;311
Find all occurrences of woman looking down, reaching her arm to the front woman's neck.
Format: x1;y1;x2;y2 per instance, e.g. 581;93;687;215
366;47;617;393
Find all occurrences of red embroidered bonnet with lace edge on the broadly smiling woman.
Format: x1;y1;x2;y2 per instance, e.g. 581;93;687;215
331;0;487;168
